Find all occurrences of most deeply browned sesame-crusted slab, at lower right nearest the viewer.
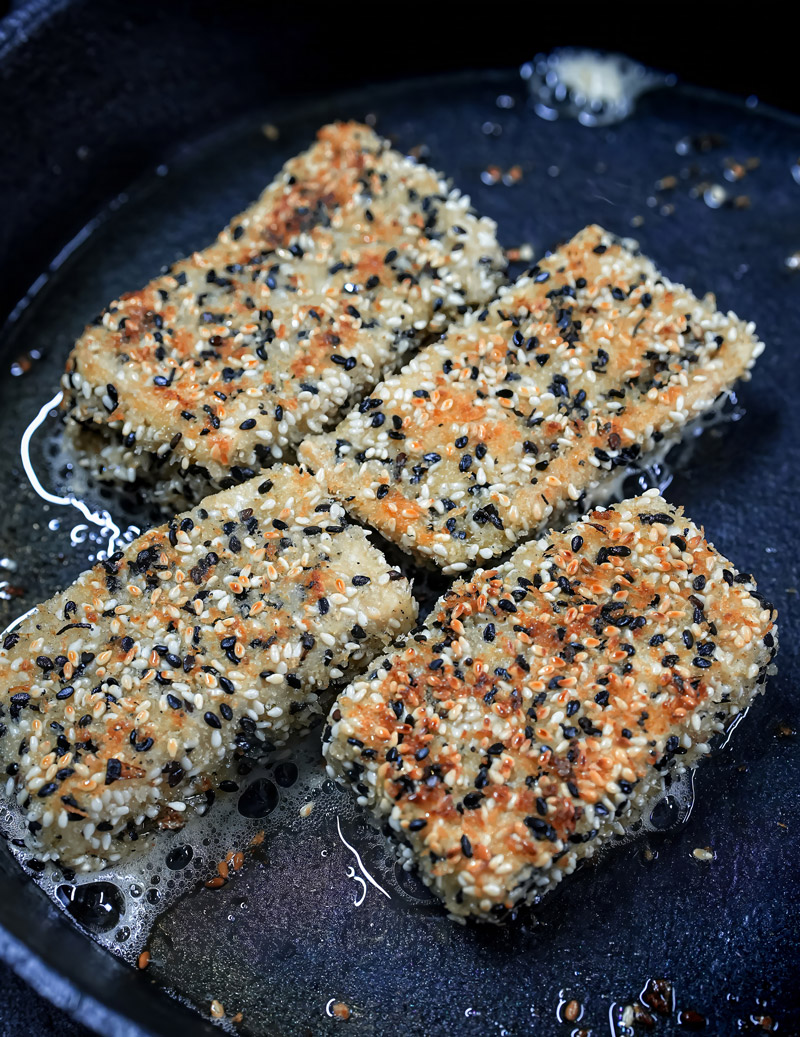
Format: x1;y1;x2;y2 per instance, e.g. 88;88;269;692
324;491;777;920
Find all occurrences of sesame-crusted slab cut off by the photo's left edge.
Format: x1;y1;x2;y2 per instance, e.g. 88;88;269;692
0;465;416;871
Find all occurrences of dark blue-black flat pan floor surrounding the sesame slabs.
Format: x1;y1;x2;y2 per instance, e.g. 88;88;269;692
0;73;800;1035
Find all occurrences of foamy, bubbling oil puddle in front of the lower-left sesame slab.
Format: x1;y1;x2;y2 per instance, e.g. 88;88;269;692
0;729;435;964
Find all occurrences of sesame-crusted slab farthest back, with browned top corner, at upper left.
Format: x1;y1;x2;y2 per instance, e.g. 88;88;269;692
62;122;504;505
